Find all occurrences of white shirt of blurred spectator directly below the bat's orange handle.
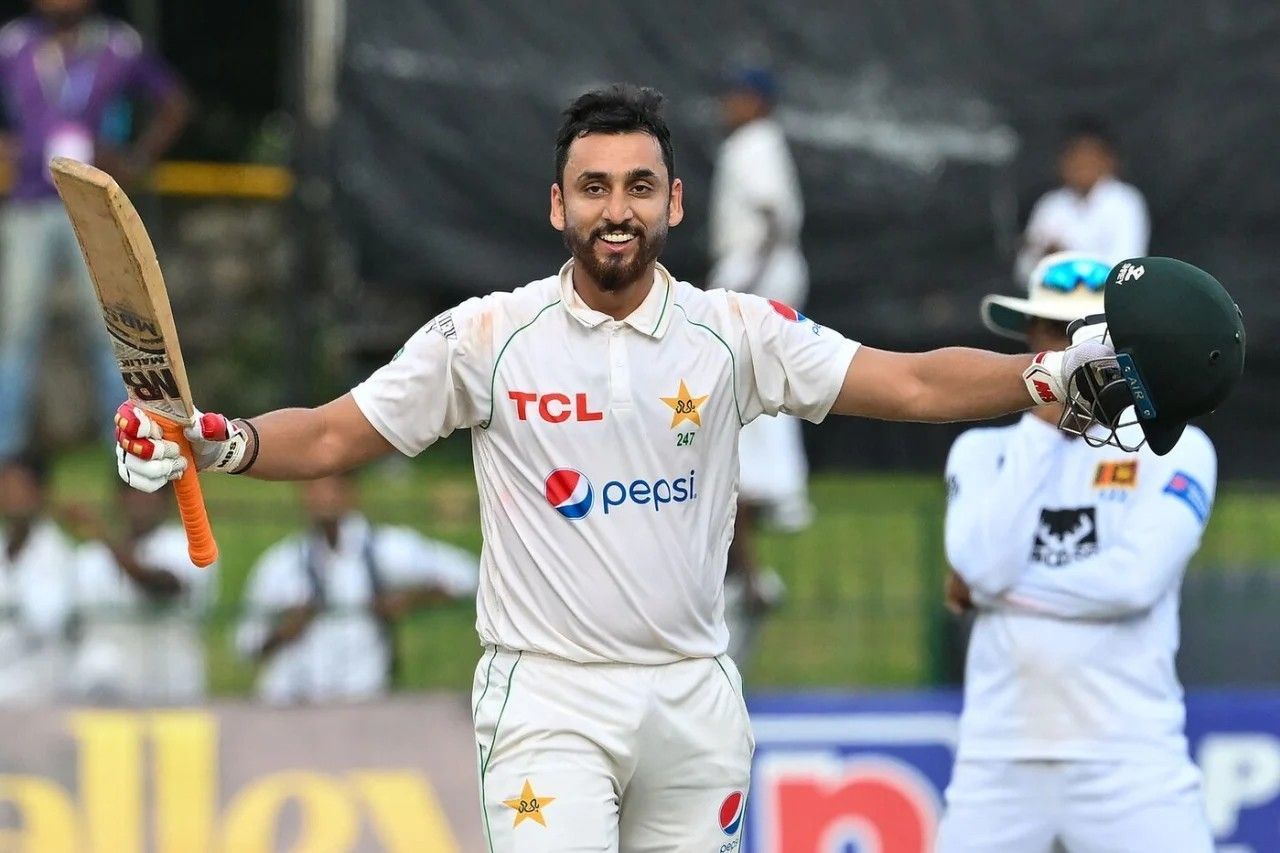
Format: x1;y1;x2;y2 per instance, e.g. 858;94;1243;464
72;524;218;704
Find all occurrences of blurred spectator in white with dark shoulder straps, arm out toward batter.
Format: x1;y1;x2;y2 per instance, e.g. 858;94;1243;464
236;473;479;703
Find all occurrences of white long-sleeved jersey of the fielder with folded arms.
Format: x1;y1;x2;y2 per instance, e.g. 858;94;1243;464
946;415;1217;760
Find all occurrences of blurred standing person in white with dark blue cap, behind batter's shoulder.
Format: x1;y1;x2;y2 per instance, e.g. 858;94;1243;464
708;68;813;671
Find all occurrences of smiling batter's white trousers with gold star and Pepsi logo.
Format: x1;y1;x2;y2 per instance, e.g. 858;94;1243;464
472;647;755;853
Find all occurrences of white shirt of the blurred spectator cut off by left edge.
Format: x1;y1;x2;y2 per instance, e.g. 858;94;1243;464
0;520;76;704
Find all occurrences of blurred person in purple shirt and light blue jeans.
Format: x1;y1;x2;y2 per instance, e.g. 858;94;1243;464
0;0;188;459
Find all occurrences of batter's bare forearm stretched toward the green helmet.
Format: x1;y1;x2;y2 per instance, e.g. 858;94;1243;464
831;346;1061;423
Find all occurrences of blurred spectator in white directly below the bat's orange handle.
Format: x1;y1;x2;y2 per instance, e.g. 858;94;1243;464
70;482;216;704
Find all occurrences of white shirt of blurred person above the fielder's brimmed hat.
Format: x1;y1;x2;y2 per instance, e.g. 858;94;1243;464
1018;178;1151;282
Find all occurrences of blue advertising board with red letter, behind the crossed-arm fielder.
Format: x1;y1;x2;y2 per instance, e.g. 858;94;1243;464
747;690;1280;853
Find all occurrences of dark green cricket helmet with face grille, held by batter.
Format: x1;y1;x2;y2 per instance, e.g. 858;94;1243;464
1073;257;1244;456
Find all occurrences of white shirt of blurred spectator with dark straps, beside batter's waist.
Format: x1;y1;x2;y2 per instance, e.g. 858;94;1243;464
236;514;476;704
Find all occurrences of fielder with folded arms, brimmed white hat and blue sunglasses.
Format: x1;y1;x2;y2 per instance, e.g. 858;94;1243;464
937;254;1217;853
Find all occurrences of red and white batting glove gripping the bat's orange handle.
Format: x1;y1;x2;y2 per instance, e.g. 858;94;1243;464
115;402;250;492
